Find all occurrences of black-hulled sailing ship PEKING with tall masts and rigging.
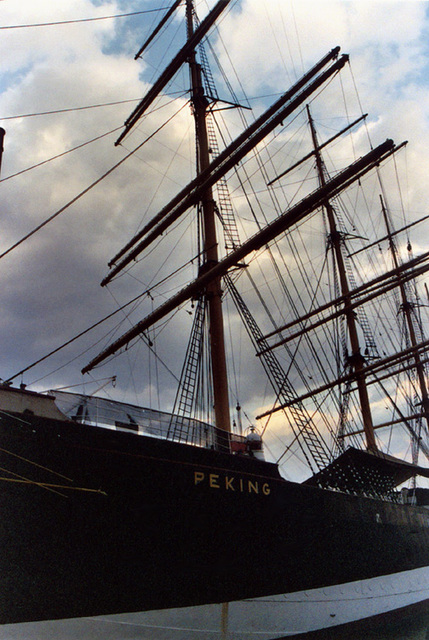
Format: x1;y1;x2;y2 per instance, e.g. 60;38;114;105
0;0;429;640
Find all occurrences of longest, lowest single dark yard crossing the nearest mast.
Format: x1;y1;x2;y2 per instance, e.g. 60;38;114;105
82;140;396;373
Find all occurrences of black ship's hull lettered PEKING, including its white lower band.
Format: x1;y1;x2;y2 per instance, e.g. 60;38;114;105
0;416;429;639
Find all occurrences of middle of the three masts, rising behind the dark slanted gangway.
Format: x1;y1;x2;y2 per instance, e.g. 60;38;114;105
307;106;377;451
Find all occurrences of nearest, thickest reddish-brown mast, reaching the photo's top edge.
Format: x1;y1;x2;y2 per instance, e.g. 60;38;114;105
186;0;231;440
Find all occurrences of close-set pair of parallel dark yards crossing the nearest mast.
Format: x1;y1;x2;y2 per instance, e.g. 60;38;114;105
101;47;348;286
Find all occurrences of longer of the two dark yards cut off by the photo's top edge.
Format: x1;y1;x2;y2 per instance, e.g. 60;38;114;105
115;0;231;146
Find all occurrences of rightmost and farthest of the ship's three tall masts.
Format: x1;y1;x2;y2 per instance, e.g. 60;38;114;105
380;195;429;436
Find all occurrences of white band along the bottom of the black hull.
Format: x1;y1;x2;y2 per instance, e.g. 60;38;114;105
0;567;429;640
